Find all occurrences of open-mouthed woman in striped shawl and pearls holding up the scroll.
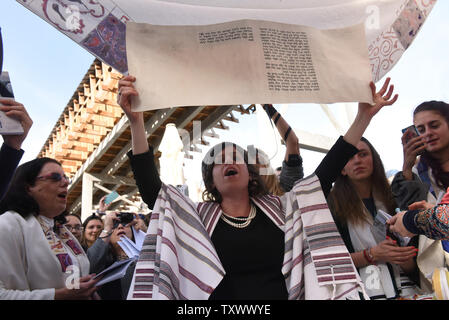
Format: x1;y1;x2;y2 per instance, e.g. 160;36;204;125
118;76;390;300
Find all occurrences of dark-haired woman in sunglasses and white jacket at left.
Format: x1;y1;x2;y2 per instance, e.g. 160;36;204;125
0;158;98;300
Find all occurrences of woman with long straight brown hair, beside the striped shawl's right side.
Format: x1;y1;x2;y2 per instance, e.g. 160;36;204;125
316;131;416;299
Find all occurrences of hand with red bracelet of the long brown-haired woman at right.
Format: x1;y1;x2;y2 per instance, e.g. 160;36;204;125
371;238;418;265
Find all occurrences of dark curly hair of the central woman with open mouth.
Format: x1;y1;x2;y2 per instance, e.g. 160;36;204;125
201;142;268;203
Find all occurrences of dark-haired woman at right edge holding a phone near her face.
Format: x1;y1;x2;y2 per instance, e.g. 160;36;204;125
392;101;449;291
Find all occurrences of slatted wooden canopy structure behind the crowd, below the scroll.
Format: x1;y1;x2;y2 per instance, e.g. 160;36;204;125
38;60;255;220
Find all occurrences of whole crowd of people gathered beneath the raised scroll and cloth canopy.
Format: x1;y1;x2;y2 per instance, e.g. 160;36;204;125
0;31;449;300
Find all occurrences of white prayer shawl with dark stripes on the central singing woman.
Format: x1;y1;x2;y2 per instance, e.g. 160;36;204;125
128;175;368;300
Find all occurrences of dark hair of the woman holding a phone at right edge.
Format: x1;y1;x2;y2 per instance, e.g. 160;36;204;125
413;100;449;190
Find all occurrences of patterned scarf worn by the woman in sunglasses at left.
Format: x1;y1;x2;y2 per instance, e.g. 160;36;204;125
36;216;83;272
